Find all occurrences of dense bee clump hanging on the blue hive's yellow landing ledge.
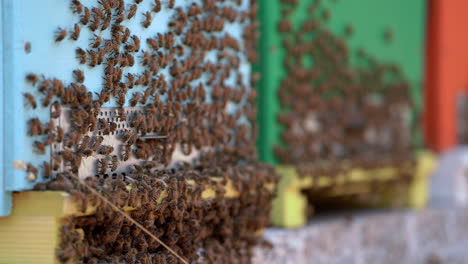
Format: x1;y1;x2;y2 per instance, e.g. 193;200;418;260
37;159;277;263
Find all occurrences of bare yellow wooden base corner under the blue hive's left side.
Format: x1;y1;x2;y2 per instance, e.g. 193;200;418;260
0;192;78;264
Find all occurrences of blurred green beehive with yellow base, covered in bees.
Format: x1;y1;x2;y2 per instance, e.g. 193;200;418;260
258;0;434;227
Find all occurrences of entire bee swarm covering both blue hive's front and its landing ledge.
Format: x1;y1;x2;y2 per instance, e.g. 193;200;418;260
24;0;278;263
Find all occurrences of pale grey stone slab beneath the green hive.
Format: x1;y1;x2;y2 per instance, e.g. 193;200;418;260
254;208;468;264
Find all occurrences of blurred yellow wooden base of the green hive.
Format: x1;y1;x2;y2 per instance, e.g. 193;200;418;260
272;152;436;228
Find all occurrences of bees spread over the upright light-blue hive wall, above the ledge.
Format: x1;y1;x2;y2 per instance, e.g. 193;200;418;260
24;0;258;182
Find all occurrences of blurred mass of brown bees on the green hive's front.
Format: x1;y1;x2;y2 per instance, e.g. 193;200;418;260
275;0;414;178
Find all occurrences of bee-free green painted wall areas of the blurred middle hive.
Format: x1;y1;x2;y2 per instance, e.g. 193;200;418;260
257;0;426;164
